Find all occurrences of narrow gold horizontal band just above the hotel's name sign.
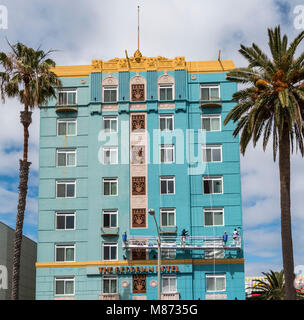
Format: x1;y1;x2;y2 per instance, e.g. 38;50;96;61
36;259;245;268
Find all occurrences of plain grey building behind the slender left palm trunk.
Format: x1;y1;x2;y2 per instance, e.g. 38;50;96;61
0;222;37;300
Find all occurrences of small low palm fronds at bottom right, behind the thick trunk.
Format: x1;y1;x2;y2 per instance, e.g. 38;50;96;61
250;269;304;300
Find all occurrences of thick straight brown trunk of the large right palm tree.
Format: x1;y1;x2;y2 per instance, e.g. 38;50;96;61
279;124;296;300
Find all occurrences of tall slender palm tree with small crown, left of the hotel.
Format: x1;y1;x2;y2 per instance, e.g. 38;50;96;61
0;42;60;300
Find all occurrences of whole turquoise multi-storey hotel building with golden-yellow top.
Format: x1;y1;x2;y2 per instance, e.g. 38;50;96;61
36;50;245;300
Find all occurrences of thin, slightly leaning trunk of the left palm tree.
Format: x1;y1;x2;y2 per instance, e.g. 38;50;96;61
12;107;32;300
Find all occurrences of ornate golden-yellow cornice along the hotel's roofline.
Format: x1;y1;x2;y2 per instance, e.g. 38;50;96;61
52;55;235;78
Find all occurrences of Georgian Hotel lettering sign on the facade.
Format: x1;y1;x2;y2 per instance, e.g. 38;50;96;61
99;266;179;274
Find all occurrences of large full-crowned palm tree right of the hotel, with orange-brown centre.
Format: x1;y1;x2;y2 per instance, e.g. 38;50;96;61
224;26;304;300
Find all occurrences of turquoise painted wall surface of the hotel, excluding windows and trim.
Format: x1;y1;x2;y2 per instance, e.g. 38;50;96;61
36;70;245;300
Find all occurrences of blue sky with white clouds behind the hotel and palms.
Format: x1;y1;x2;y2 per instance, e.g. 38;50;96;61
0;0;304;276
